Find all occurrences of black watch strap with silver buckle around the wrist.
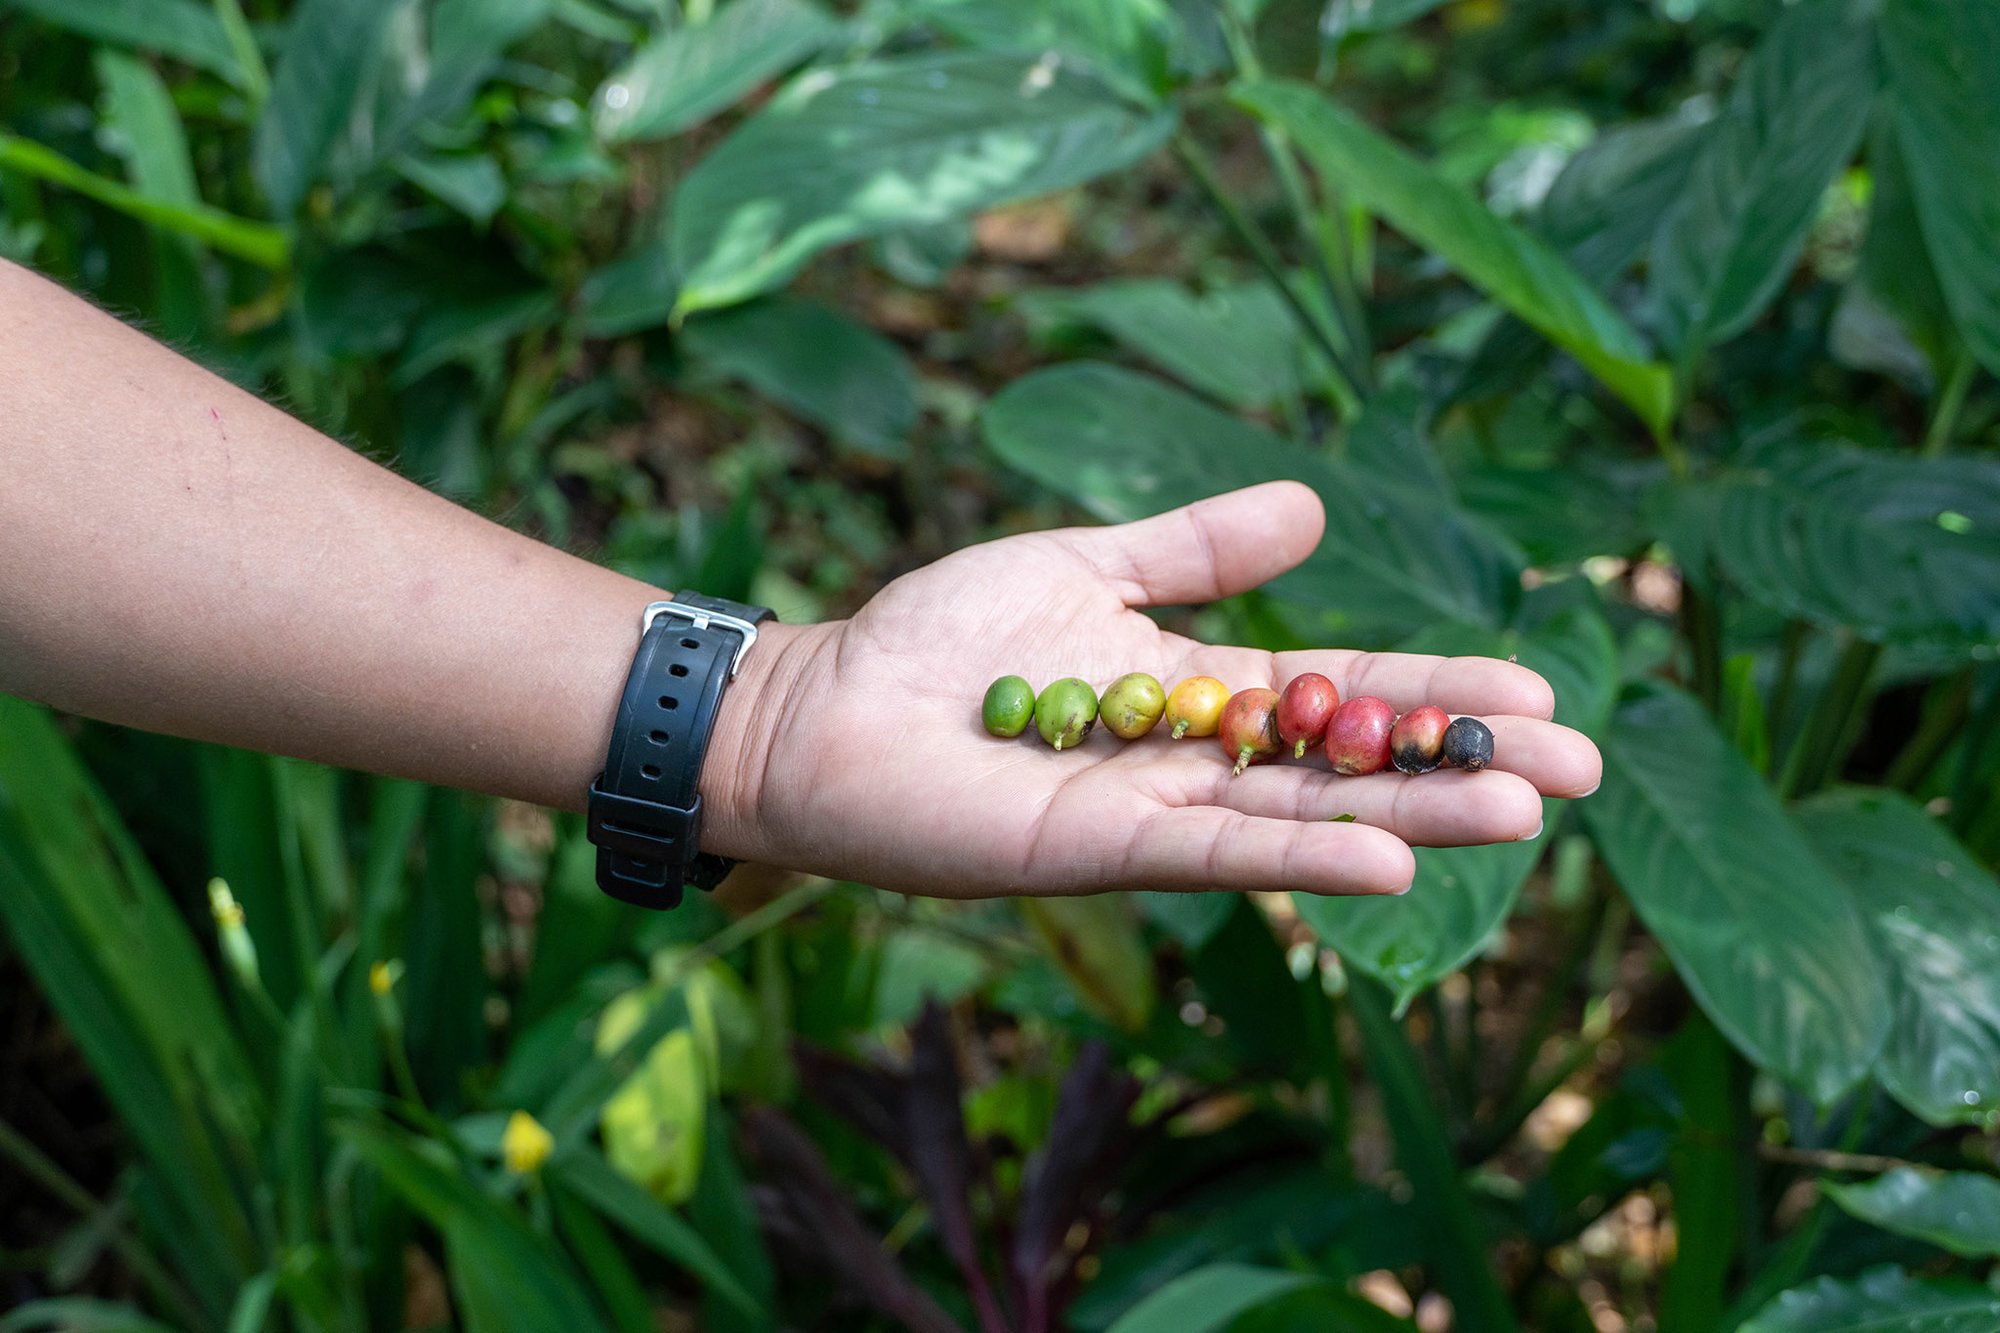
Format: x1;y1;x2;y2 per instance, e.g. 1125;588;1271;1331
590;592;772;909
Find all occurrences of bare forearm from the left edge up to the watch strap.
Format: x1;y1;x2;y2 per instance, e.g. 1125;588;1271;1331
0;262;784;824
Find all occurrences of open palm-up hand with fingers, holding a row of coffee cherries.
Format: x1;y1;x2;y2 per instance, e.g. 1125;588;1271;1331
704;482;1600;897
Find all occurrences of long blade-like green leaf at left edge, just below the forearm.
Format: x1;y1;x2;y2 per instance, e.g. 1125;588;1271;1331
0;695;262;1303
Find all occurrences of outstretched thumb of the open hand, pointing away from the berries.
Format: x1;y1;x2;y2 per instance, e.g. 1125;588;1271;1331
1050;480;1326;606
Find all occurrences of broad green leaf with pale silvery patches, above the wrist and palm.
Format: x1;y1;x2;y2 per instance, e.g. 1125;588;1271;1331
672;52;1176;314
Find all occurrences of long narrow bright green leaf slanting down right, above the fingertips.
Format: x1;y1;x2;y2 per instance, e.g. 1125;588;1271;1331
1236;82;1674;434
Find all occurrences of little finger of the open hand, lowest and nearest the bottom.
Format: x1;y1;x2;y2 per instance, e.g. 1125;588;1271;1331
1126;805;1416;895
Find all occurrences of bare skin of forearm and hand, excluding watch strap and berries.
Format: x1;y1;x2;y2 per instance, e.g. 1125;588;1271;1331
0;262;1600;897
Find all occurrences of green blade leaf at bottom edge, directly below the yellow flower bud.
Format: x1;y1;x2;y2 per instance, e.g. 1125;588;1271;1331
340;1123;604;1333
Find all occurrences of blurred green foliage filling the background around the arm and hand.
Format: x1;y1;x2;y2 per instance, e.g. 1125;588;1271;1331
0;0;2000;1333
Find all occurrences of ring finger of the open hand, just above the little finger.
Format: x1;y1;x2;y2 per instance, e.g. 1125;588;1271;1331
1208;765;1542;847
